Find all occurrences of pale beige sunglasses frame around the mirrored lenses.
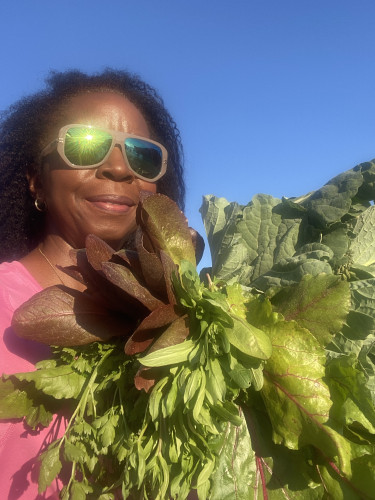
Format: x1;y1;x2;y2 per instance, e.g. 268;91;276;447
41;123;168;182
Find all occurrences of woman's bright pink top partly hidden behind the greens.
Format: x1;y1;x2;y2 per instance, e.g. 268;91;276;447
0;261;61;500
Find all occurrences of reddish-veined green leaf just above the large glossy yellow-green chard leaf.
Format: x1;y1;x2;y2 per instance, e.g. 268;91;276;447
272;274;350;345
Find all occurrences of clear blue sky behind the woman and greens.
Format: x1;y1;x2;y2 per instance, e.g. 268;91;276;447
0;0;375;270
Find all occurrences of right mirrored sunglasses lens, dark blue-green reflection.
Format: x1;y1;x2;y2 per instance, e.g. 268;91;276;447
125;137;163;180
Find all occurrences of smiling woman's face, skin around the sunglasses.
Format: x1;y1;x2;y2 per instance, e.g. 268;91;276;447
36;92;156;249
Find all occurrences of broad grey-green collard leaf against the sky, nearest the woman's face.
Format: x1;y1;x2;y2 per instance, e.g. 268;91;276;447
201;195;302;284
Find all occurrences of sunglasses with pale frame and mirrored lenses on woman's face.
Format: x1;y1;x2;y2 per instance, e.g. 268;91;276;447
41;124;168;182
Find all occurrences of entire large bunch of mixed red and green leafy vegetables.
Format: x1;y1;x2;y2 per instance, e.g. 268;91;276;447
0;162;375;500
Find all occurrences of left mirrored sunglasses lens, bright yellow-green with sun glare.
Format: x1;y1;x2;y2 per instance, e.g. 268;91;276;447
64;127;112;167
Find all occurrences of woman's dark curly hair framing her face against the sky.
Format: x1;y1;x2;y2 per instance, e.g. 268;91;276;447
0;69;185;262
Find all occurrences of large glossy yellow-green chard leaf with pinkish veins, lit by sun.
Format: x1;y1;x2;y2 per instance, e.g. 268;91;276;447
261;322;350;474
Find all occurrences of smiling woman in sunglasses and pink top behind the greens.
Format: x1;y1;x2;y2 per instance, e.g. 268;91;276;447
0;70;184;499
